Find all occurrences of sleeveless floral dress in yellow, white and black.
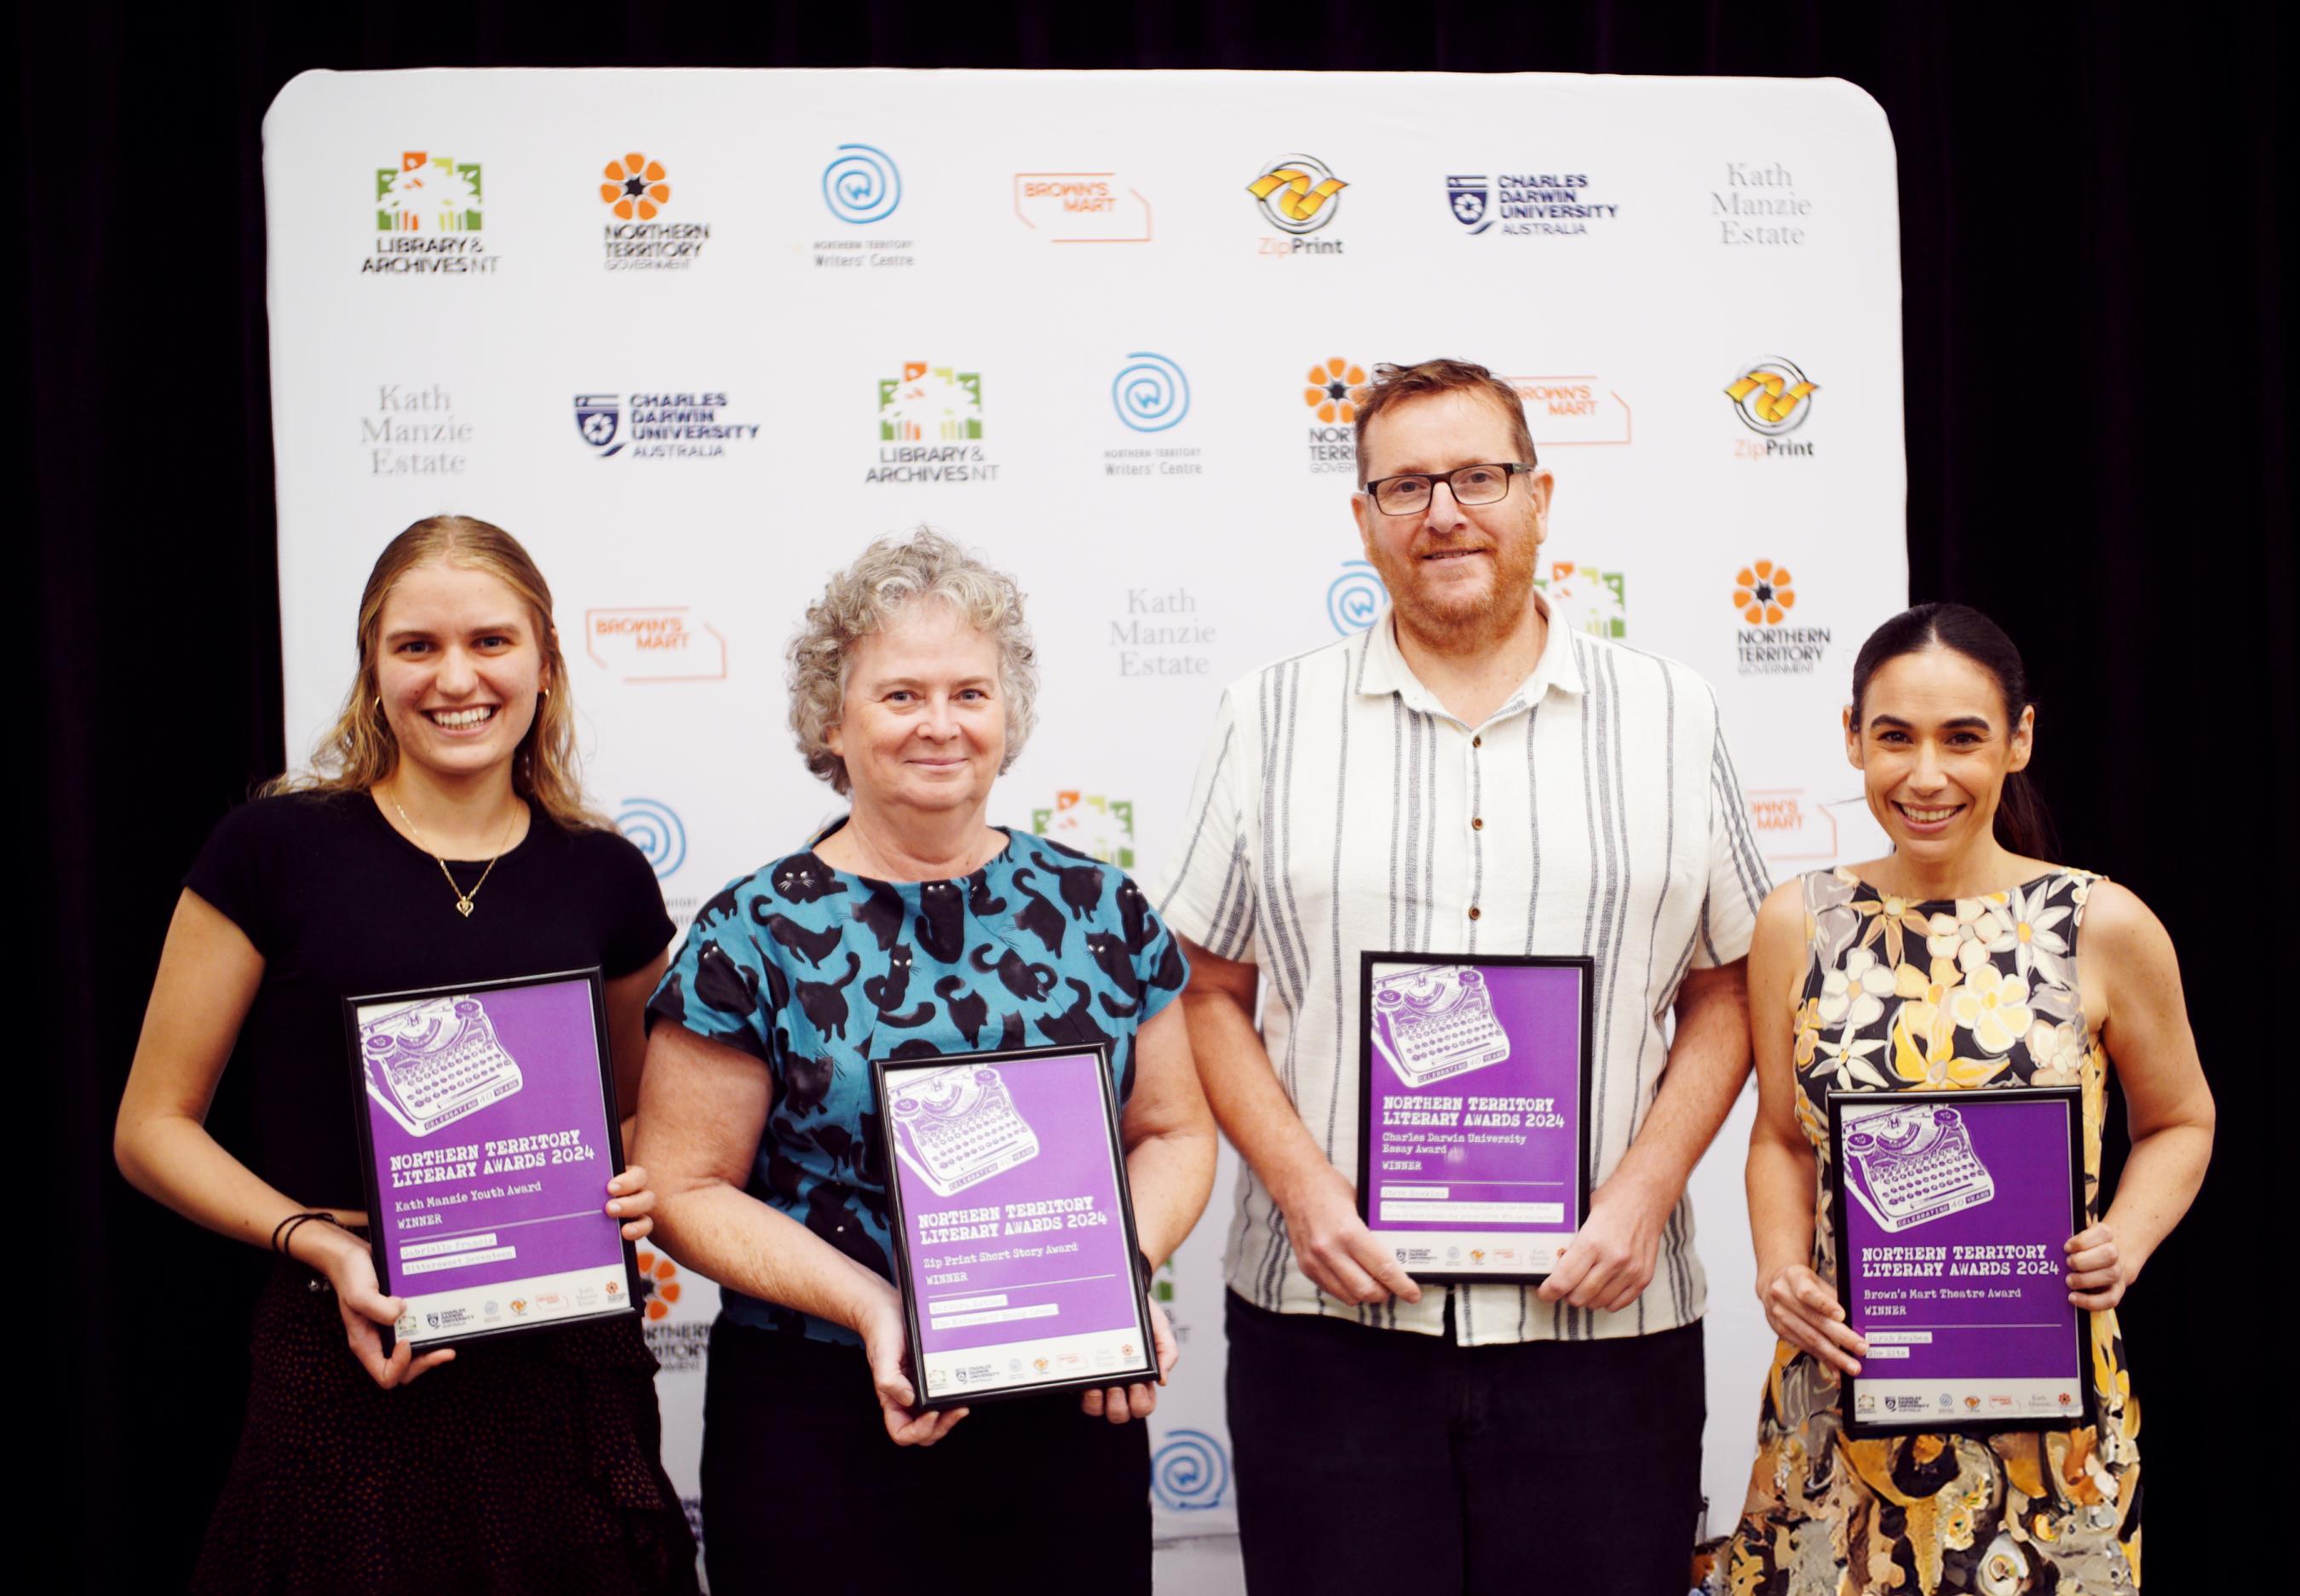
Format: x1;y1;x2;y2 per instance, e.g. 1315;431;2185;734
1695;870;2142;1596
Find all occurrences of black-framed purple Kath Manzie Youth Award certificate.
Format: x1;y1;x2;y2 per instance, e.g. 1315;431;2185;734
342;968;640;1352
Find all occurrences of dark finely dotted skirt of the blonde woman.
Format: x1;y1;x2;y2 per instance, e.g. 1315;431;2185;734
193;1262;694;1596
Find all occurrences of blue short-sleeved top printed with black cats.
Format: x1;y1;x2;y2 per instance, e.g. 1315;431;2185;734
647;830;1189;1343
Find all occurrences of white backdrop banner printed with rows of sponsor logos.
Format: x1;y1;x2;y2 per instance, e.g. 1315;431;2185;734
265;72;1906;1572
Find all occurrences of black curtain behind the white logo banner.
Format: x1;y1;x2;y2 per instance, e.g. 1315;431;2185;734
36;0;2300;1592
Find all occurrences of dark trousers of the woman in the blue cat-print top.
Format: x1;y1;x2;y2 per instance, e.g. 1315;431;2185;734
685;1318;1145;1596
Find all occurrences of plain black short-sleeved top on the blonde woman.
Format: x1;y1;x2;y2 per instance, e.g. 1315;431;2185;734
184;794;674;1208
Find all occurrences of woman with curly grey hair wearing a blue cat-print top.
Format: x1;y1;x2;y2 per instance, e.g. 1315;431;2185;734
637;529;1215;1593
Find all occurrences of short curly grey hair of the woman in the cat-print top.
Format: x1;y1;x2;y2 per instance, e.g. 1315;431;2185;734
791;526;1038;795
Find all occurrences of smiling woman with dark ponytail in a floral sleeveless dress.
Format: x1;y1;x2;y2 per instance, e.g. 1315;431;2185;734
1706;605;2212;1596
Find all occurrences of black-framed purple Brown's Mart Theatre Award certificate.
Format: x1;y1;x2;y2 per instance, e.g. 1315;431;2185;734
1829;1086;2096;1438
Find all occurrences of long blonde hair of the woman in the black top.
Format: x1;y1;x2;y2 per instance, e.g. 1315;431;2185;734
262;515;607;830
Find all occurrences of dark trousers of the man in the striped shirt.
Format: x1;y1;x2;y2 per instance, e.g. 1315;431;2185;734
1228;1288;1706;1596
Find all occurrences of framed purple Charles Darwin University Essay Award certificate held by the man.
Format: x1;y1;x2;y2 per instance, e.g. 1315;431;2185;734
1357;952;1596;1281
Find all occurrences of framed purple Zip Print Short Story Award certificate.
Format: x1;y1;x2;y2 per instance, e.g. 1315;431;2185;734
871;1044;1157;1408
